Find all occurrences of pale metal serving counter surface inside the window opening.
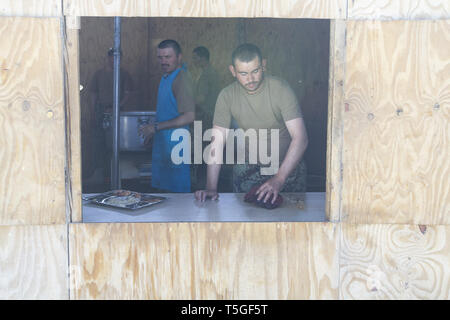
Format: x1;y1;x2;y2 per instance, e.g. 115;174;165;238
83;192;325;223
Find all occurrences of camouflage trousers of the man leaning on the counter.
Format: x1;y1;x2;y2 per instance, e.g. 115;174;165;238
233;160;306;193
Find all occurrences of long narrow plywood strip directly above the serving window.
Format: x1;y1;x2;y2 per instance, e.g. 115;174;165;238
64;0;347;19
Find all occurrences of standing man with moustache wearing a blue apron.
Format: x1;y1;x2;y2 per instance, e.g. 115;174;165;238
140;40;195;192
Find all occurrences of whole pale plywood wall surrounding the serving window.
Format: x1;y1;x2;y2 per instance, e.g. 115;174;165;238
0;0;450;300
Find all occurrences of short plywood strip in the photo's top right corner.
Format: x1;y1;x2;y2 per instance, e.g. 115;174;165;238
348;0;450;20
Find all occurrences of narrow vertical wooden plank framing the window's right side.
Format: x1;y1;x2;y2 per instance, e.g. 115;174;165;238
325;20;346;221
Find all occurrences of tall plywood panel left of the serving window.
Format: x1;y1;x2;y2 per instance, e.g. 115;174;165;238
0;17;65;225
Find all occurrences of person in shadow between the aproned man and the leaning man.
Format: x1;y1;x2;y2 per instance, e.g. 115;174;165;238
192;46;221;189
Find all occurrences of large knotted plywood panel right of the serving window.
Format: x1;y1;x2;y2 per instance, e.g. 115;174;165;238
341;21;450;224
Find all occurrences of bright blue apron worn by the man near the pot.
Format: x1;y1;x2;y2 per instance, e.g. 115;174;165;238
152;66;191;192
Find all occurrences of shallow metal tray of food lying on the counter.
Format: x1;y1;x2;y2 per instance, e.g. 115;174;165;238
82;190;166;210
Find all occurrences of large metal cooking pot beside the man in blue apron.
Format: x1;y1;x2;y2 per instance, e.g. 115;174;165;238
103;111;156;151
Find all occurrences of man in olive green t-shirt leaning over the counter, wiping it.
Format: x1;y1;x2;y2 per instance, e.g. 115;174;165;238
195;44;308;202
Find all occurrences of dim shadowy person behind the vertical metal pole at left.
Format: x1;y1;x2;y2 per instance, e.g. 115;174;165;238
89;48;134;185
